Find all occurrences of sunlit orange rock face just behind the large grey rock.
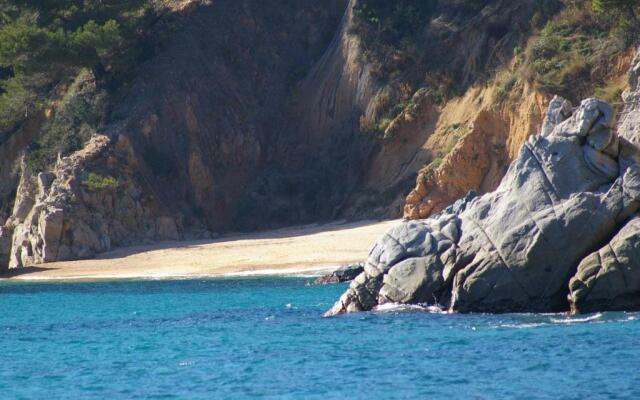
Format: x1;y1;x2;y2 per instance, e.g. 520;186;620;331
404;85;548;219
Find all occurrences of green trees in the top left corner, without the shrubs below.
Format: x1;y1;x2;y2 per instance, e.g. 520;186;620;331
0;0;170;133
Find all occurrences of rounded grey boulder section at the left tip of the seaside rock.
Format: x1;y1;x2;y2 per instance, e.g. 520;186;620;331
327;203;472;315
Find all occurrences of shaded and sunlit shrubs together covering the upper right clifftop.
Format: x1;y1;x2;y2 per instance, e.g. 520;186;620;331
352;0;640;132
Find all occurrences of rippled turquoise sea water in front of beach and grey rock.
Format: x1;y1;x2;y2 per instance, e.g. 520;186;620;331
0;278;640;399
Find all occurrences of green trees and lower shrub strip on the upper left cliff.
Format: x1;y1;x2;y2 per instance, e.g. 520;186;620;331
0;0;179;170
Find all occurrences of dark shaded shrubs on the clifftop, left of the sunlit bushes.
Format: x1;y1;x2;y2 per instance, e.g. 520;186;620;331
351;0;560;133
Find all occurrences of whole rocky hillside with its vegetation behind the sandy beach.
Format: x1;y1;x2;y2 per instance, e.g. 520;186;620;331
0;0;636;267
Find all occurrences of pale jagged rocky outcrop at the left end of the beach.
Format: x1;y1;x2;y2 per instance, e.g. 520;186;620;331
0;135;198;268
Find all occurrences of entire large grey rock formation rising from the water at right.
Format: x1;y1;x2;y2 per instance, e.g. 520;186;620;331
327;78;640;315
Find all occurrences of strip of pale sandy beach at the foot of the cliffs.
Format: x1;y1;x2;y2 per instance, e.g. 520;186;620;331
4;220;399;280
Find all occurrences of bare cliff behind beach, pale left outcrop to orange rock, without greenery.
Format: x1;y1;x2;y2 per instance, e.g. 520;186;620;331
0;0;628;267
